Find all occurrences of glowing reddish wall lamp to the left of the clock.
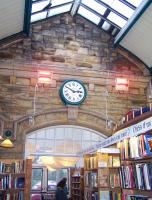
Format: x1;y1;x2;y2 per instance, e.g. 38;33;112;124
38;71;53;84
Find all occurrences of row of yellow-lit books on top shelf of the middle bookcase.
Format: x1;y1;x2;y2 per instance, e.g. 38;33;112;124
84;153;120;170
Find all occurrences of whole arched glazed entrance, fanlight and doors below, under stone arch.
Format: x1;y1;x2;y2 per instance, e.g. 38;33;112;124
25;125;106;199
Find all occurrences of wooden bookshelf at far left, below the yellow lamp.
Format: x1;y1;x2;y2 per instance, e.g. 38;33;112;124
0;159;32;200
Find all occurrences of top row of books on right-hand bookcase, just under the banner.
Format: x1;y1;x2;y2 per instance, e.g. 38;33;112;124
120;134;152;160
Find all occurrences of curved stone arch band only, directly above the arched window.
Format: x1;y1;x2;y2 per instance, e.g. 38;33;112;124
15;108;111;136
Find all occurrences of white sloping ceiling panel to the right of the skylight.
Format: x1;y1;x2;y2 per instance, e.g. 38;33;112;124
116;0;152;68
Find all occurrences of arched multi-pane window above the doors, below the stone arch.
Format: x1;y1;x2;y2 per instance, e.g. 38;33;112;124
25;125;106;157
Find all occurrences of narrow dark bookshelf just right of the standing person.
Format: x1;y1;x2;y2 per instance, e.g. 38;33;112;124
71;168;84;200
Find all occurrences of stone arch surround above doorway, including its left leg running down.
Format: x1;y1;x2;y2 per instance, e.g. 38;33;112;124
1;107;111;158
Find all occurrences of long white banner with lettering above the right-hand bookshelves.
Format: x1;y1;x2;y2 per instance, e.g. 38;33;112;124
80;117;152;154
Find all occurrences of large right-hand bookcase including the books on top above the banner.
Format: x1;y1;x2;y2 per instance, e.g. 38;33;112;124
117;111;152;200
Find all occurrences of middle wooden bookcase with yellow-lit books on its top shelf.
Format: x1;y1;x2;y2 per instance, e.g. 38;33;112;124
84;148;121;200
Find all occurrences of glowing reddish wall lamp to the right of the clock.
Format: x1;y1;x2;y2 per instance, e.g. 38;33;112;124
115;78;129;91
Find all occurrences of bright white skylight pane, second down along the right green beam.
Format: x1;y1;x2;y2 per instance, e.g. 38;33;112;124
111;0;134;18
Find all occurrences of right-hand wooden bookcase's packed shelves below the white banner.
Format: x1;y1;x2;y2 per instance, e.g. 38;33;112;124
118;132;152;200
